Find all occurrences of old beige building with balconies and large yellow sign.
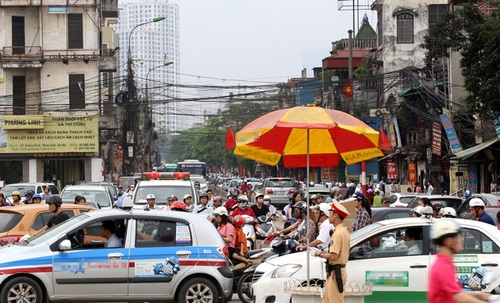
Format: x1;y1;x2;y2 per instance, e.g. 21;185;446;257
0;0;117;186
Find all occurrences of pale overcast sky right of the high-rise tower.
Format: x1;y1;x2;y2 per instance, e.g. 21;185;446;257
178;0;376;85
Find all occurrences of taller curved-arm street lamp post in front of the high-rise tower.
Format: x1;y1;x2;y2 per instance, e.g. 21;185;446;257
122;16;165;176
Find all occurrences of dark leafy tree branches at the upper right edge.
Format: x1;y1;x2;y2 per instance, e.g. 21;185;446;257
421;2;500;117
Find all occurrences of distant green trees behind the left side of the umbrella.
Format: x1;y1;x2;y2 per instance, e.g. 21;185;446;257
167;99;278;172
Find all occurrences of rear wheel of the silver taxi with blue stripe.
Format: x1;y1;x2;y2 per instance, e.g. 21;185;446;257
178;278;219;303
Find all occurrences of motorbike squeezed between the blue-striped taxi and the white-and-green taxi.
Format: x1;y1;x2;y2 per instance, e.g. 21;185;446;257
237;234;299;303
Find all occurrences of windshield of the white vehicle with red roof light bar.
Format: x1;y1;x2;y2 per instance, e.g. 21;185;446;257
134;185;194;205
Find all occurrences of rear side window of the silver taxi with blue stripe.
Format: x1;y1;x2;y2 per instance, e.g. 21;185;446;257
135;220;192;247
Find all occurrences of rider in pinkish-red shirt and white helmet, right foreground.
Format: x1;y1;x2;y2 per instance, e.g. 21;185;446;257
427;218;493;303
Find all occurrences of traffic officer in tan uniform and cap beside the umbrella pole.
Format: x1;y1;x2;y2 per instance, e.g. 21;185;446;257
310;201;351;303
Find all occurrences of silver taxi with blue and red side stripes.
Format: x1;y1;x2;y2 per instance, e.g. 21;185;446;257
0;209;233;303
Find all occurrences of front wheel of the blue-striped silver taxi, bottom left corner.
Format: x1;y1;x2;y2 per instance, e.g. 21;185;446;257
0;277;43;303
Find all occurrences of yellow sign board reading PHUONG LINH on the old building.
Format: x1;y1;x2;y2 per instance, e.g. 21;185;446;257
0;115;99;154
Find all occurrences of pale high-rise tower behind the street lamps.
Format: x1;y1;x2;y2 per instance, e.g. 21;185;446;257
115;0;181;131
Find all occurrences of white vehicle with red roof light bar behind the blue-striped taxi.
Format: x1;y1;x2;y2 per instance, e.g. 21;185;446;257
132;172;198;208
